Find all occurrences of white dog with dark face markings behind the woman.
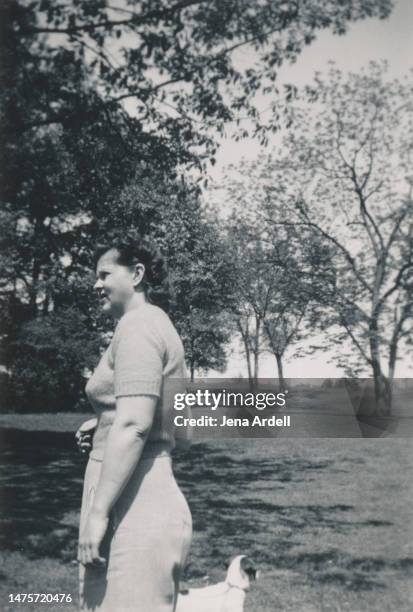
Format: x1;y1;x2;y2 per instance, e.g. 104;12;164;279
176;555;258;612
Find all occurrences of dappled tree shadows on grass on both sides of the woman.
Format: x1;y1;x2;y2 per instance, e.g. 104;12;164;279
0;429;413;590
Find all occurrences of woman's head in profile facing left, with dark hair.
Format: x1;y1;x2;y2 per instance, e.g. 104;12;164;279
94;240;169;317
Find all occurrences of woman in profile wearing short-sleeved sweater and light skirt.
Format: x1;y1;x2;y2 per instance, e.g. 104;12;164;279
79;243;192;612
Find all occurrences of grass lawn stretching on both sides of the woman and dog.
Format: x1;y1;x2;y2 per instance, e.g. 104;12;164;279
0;415;413;612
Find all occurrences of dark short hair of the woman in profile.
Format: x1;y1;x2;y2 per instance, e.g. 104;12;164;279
94;238;170;312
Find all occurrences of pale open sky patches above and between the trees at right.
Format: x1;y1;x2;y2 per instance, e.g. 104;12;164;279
205;0;413;378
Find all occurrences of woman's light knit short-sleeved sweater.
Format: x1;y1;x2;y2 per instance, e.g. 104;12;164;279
85;302;187;460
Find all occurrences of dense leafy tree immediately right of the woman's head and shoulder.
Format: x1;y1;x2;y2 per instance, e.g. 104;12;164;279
159;193;234;380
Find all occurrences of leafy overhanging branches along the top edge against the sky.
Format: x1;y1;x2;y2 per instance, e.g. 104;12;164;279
1;0;391;167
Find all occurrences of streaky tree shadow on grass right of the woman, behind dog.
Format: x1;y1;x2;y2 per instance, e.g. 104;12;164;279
175;443;413;591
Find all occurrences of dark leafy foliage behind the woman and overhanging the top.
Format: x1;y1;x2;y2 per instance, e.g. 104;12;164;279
0;0;396;408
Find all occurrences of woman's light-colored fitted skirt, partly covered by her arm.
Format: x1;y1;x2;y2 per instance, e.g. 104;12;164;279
79;454;192;612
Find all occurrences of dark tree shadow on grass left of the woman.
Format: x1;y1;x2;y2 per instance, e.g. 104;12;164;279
0;429;85;560
